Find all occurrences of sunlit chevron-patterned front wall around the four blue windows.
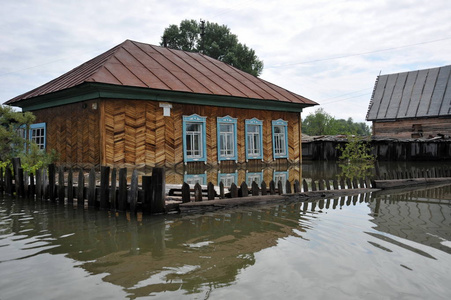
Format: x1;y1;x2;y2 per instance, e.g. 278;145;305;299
100;99;301;167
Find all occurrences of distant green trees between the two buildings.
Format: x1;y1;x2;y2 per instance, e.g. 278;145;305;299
302;108;371;135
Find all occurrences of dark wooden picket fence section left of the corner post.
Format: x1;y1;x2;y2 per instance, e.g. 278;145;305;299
0;158;165;214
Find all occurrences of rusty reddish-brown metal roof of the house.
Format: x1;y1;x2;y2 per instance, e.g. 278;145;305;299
6;40;317;105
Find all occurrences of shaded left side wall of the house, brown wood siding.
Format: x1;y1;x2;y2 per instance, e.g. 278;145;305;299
33;101;101;166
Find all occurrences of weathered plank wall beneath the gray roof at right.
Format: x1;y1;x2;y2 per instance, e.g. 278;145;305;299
373;118;451;138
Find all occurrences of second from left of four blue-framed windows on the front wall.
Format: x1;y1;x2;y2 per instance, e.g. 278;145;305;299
217;116;238;161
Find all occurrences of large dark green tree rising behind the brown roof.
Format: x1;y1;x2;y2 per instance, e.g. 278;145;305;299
160;20;263;76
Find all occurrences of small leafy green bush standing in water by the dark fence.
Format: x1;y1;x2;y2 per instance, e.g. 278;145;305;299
337;136;376;180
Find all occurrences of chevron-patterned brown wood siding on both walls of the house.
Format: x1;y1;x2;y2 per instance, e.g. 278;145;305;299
35;99;300;167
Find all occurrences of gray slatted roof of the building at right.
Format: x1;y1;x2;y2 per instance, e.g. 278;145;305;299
366;65;451;121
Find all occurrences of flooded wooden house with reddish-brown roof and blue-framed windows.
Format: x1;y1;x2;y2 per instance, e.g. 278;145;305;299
6;40;317;166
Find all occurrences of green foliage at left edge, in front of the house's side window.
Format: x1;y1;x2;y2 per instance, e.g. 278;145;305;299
0;105;57;173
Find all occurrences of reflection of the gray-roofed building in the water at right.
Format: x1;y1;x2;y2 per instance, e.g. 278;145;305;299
369;186;451;254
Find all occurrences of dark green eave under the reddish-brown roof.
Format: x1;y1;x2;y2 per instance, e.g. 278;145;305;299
9;83;317;112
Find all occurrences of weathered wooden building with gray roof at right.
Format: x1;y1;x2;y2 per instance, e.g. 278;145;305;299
366;66;451;138
